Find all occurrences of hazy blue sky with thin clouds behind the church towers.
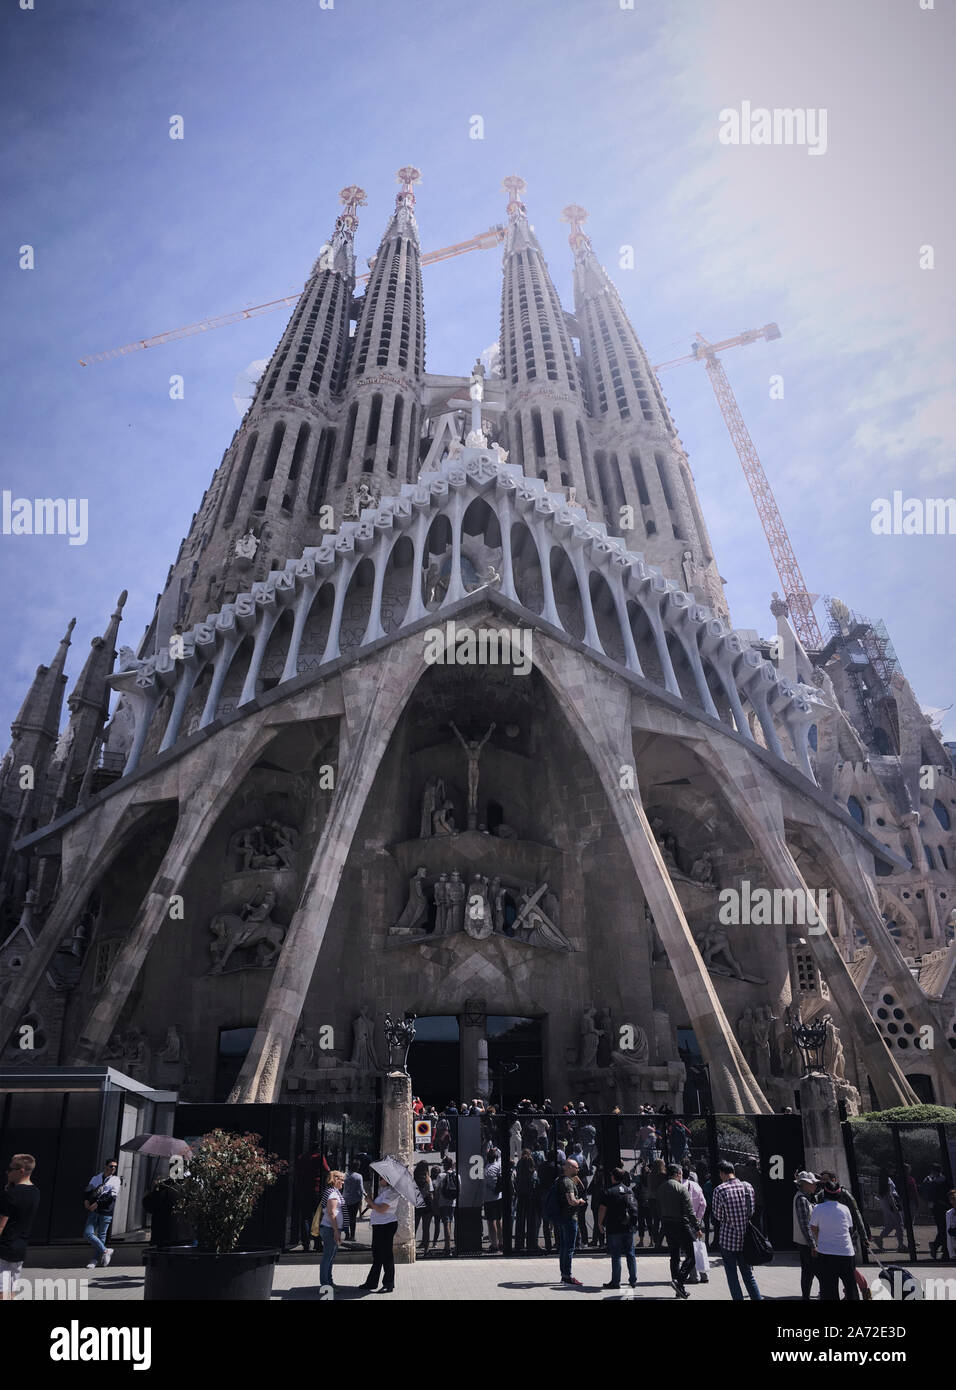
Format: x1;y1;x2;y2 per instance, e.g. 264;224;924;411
0;0;956;738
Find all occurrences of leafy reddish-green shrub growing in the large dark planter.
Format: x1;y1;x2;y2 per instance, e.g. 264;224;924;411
176;1129;288;1255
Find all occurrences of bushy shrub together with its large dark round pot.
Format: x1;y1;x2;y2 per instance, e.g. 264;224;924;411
143;1129;286;1302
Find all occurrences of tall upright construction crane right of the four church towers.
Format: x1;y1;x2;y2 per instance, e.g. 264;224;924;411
654;324;824;652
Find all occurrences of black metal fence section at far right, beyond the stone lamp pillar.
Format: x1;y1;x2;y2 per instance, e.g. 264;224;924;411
843;1120;956;1264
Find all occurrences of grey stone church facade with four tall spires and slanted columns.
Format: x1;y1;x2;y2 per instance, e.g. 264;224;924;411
0;167;956;1113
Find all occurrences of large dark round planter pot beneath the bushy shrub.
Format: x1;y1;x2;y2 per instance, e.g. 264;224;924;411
143;1245;279;1302
